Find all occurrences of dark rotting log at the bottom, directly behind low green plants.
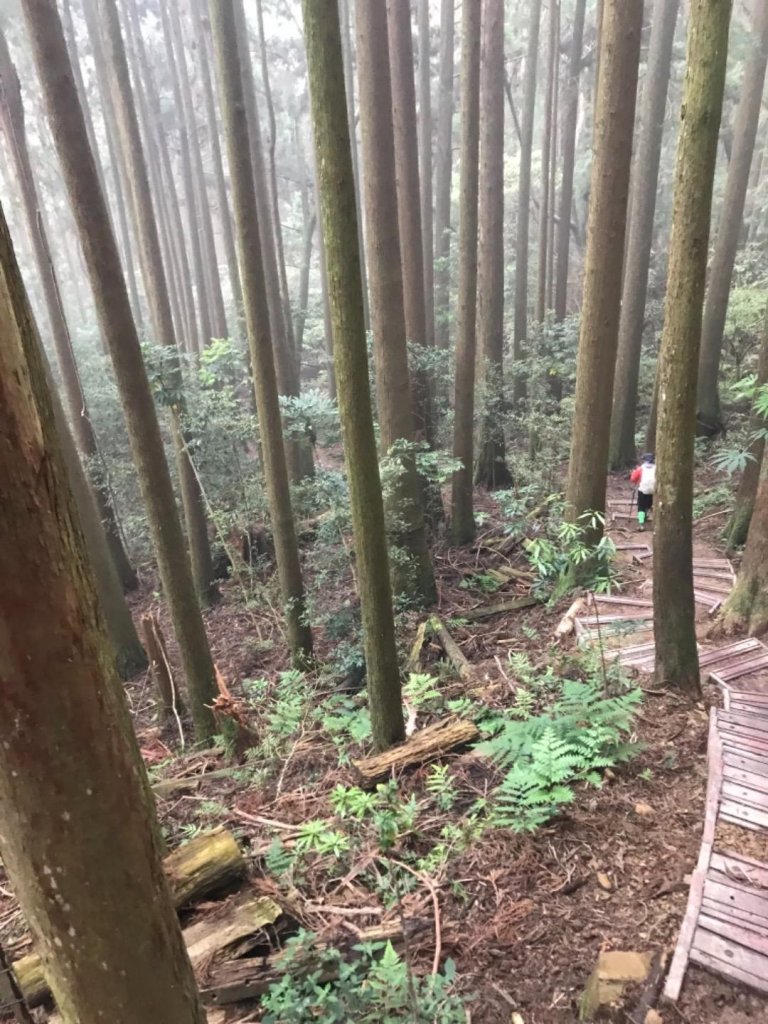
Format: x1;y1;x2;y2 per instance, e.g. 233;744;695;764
200;921;427;1007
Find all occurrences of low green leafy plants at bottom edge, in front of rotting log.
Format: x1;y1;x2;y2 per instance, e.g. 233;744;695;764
262;933;466;1024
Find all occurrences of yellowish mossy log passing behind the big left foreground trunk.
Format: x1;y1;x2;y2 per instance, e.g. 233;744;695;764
12;828;246;1007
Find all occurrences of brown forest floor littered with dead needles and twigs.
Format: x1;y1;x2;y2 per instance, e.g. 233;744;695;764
0;468;768;1024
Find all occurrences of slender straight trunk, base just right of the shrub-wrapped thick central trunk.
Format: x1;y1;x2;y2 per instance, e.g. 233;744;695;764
451;3;481;544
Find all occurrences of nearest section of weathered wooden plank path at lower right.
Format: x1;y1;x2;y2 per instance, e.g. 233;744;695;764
665;675;768;1002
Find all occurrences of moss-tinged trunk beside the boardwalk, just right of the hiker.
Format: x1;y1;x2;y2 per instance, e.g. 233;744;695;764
653;0;731;695
